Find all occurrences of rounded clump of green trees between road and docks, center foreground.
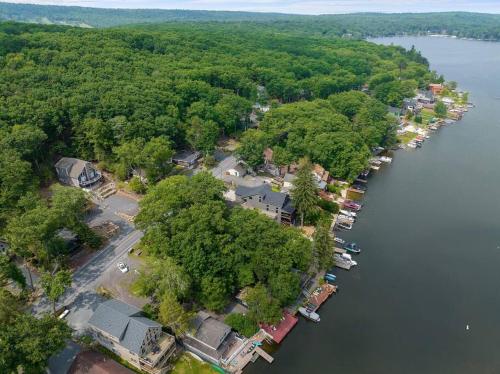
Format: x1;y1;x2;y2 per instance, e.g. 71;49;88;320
136;173;311;310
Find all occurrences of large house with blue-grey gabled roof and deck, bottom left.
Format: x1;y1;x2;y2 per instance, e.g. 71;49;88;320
89;300;176;374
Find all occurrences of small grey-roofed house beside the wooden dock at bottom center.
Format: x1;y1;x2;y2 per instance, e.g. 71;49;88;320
182;311;246;366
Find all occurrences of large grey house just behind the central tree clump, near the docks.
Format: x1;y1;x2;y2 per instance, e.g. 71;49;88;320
235;184;295;225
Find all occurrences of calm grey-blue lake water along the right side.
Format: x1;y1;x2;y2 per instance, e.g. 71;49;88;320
247;37;500;374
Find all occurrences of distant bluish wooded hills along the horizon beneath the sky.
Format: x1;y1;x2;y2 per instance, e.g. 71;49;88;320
0;3;500;40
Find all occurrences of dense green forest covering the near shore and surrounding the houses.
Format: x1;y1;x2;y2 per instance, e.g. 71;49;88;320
0;22;442;366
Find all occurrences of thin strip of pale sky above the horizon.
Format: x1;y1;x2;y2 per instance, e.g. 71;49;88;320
0;0;500;14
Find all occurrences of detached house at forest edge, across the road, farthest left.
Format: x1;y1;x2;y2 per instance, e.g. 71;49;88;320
55;157;102;188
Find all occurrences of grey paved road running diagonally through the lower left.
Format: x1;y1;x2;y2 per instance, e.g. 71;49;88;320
32;229;143;331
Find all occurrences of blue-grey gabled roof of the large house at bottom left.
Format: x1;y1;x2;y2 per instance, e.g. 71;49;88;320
89;300;161;354
